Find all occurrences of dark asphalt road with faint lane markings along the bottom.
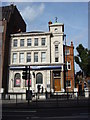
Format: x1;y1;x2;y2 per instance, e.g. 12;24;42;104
2;107;90;120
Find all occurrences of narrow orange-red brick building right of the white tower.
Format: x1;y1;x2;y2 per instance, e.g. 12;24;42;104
64;42;75;91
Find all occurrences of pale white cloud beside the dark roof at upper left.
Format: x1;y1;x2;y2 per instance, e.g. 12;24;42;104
20;3;45;22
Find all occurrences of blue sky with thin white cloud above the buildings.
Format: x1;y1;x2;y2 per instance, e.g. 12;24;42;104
2;0;88;72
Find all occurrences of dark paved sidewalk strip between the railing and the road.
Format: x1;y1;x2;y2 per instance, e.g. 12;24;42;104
2;99;90;109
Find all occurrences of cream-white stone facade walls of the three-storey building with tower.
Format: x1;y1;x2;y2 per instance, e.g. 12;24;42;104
8;23;64;92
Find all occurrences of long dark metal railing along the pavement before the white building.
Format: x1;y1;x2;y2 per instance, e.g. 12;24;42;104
1;91;90;107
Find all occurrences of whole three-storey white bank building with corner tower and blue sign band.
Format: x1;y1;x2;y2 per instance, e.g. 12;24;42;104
8;21;74;95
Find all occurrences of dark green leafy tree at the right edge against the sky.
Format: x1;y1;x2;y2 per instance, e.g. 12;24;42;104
75;44;90;77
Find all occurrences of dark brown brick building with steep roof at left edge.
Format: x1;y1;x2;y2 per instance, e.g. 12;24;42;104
0;4;26;92
